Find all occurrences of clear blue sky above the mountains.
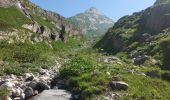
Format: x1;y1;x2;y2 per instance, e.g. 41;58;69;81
31;0;156;21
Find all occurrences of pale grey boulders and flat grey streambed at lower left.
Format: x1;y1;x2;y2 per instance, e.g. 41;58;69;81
0;60;72;100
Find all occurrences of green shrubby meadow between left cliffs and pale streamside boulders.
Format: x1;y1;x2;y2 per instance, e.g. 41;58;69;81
0;39;80;75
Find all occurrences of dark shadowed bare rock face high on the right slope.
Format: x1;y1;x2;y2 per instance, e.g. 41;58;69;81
141;3;170;34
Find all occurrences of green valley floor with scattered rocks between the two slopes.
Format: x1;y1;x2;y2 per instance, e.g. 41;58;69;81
0;40;170;100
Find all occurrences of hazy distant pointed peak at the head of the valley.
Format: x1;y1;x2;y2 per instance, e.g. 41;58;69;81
68;7;114;37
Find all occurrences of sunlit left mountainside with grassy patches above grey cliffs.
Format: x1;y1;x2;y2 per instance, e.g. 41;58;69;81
0;0;81;42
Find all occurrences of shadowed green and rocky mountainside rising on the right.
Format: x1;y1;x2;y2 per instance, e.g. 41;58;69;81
96;0;170;69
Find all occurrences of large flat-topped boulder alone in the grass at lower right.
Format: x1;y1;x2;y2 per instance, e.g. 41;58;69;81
110;81;129;90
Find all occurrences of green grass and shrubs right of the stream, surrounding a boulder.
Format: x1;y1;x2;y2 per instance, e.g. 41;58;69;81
60;49;170;100
